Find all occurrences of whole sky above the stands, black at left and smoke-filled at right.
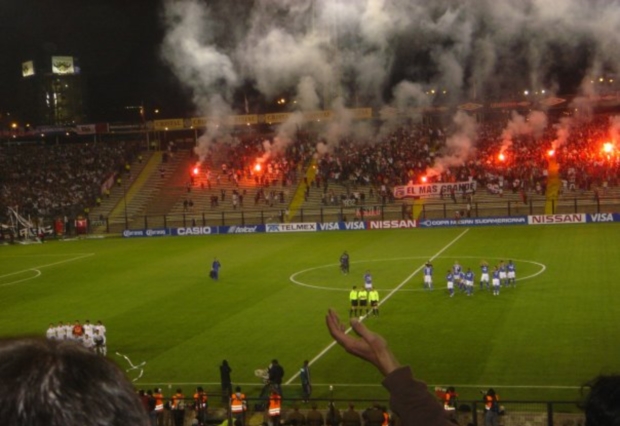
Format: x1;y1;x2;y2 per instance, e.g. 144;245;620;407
0;0;620;127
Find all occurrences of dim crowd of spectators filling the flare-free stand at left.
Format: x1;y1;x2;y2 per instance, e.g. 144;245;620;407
0;142;139;218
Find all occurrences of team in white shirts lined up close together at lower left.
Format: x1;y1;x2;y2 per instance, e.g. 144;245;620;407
45;320;108;356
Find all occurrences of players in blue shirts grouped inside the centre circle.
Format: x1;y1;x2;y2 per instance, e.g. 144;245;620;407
423;260;517;297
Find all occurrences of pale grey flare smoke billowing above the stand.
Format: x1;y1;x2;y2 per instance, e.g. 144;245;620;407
161;0;620;161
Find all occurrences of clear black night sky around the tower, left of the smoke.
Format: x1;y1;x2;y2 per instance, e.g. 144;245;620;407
0;0;192;121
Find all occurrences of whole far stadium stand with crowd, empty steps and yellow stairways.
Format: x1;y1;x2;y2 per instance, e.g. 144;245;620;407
0;114;620;232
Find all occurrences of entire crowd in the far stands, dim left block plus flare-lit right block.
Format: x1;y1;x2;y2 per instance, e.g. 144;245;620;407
0;114;620;226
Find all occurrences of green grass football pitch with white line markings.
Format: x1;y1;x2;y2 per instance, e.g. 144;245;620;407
0;224;620;400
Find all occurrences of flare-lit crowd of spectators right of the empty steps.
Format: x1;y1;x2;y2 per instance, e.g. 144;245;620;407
207;110;620;205
